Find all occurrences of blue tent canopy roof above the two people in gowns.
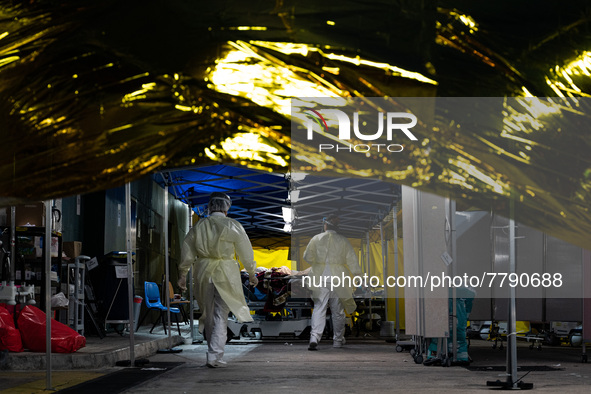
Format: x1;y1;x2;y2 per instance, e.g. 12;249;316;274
155;164;400;247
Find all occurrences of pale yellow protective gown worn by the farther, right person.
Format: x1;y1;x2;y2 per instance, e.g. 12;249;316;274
304;230;362;314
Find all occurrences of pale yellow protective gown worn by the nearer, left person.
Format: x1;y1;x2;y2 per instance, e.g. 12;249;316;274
179;212;256;332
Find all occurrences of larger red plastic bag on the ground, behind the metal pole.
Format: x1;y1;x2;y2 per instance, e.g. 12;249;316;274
18;305;86;353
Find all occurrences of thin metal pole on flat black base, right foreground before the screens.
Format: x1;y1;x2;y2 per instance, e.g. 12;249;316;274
507;198;518;389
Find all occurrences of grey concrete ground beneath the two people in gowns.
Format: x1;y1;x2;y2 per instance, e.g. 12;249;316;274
0;329;591;393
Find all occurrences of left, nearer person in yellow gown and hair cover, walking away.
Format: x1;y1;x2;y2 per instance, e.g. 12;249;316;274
178;192;258;368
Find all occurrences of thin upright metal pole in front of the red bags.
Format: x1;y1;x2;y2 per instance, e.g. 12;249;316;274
44;200;53;390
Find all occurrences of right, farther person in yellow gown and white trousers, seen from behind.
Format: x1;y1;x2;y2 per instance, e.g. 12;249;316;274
304;215;361;350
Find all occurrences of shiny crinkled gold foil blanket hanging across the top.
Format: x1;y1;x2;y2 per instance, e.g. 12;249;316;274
0;0;591;247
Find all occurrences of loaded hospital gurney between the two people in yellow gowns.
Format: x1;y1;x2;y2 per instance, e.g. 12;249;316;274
228;270;312;339
